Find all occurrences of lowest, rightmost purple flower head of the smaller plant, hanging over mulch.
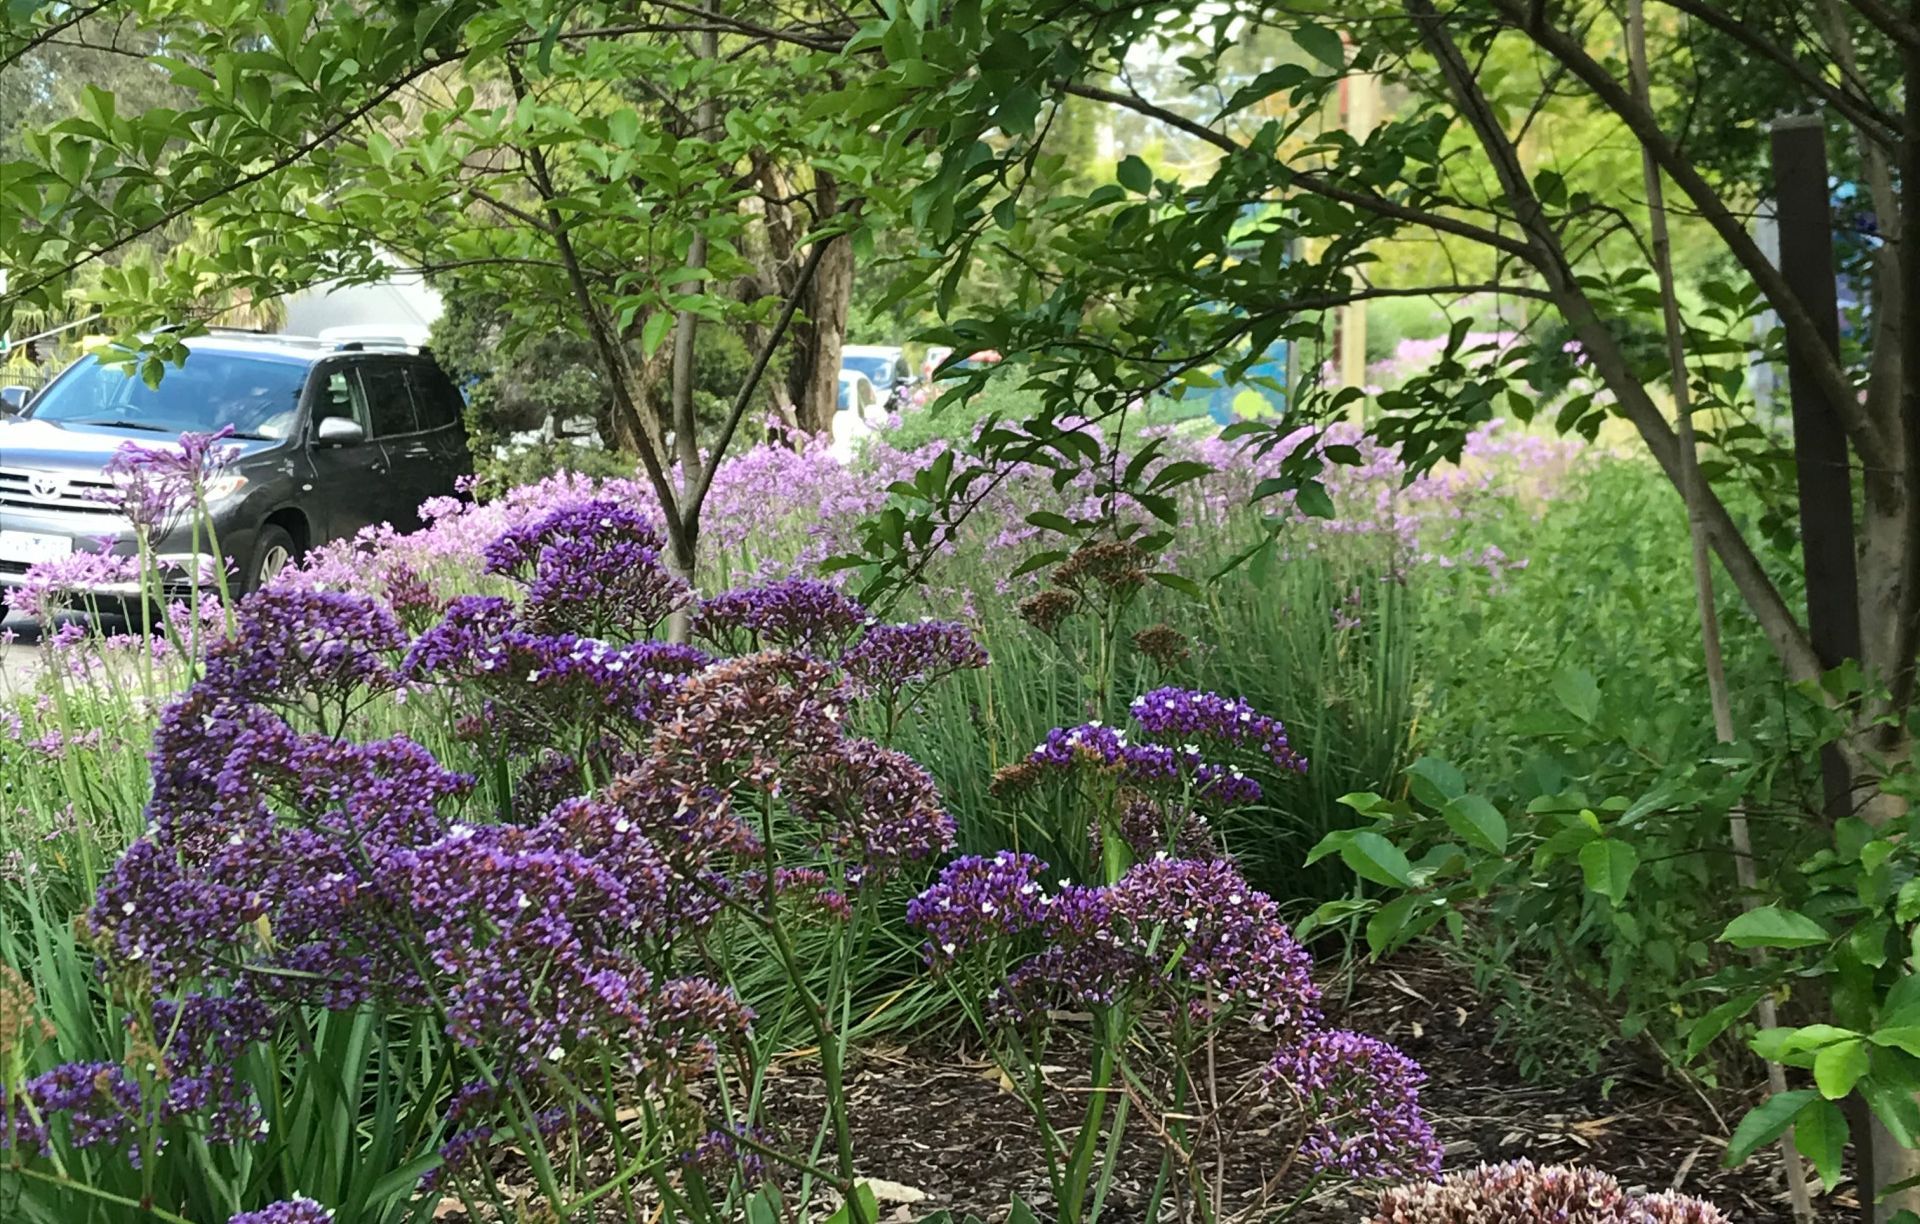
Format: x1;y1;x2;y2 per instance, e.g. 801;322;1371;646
1265;1028;1440;1182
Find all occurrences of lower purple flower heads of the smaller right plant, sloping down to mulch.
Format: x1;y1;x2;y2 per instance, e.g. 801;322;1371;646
906;852;1440;1180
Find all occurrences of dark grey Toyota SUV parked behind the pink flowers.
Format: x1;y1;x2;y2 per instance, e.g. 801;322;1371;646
0;332;472;595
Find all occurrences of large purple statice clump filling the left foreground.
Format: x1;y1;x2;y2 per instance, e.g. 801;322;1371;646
0;503;985;1220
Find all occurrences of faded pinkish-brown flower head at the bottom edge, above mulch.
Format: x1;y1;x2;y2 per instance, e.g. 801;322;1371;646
1367;1161;1728;1224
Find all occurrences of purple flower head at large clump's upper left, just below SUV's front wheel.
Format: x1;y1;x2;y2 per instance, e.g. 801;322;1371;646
207;585;407;708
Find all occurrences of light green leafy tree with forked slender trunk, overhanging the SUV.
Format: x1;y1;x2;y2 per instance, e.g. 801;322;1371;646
0;0;897;583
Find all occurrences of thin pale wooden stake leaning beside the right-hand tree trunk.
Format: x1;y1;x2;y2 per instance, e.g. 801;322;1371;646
1626;0;1812;1224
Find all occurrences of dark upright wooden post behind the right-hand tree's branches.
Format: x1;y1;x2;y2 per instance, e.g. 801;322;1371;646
1772;115;1860;819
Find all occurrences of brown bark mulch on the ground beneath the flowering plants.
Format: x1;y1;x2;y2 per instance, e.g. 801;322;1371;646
770;961;1859;1224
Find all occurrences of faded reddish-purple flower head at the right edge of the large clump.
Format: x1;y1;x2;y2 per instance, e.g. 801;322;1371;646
787;739;954;884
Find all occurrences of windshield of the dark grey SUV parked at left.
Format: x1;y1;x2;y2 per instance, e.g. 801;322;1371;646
33;351;307;437
